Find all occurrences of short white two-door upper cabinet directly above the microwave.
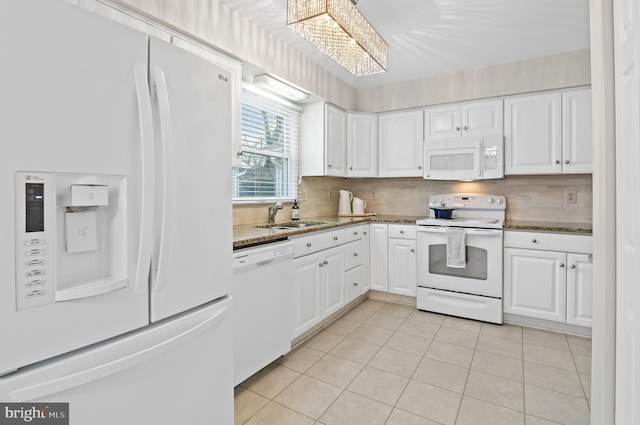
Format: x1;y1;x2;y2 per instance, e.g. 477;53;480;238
424;99;503;142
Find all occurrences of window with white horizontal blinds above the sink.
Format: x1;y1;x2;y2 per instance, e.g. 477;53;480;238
233;87;301;201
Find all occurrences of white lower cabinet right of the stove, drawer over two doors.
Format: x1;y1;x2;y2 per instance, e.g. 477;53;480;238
504;231;593;327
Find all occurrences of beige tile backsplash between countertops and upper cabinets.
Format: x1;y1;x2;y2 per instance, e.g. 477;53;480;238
233;174;592;224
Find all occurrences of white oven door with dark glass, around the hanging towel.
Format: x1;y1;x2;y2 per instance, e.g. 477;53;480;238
417;226;502;298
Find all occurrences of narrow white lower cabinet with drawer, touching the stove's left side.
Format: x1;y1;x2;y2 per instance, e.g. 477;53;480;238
388;224;417;297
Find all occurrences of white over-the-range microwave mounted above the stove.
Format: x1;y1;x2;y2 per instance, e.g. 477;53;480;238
423;136;504;180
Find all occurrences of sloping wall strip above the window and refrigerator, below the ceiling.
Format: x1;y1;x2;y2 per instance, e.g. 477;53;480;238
112;0;356;110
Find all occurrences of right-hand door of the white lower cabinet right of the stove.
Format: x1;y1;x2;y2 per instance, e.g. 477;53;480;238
567;254;593;327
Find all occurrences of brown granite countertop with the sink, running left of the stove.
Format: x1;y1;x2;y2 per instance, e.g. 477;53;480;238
233;215;423;249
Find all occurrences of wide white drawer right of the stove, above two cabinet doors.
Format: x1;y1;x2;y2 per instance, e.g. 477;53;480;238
504;231;593;254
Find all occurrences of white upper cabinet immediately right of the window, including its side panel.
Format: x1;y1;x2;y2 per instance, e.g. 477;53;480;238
300;102;347;177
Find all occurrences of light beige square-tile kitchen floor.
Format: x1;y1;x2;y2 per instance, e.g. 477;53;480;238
235;299;591;425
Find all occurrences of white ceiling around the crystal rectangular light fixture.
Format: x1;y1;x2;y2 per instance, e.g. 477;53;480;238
220;0;589;89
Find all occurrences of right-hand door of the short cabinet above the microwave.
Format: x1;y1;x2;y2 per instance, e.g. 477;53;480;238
460;100;504;137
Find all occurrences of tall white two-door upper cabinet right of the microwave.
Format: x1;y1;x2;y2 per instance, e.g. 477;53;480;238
504;89;591;174
